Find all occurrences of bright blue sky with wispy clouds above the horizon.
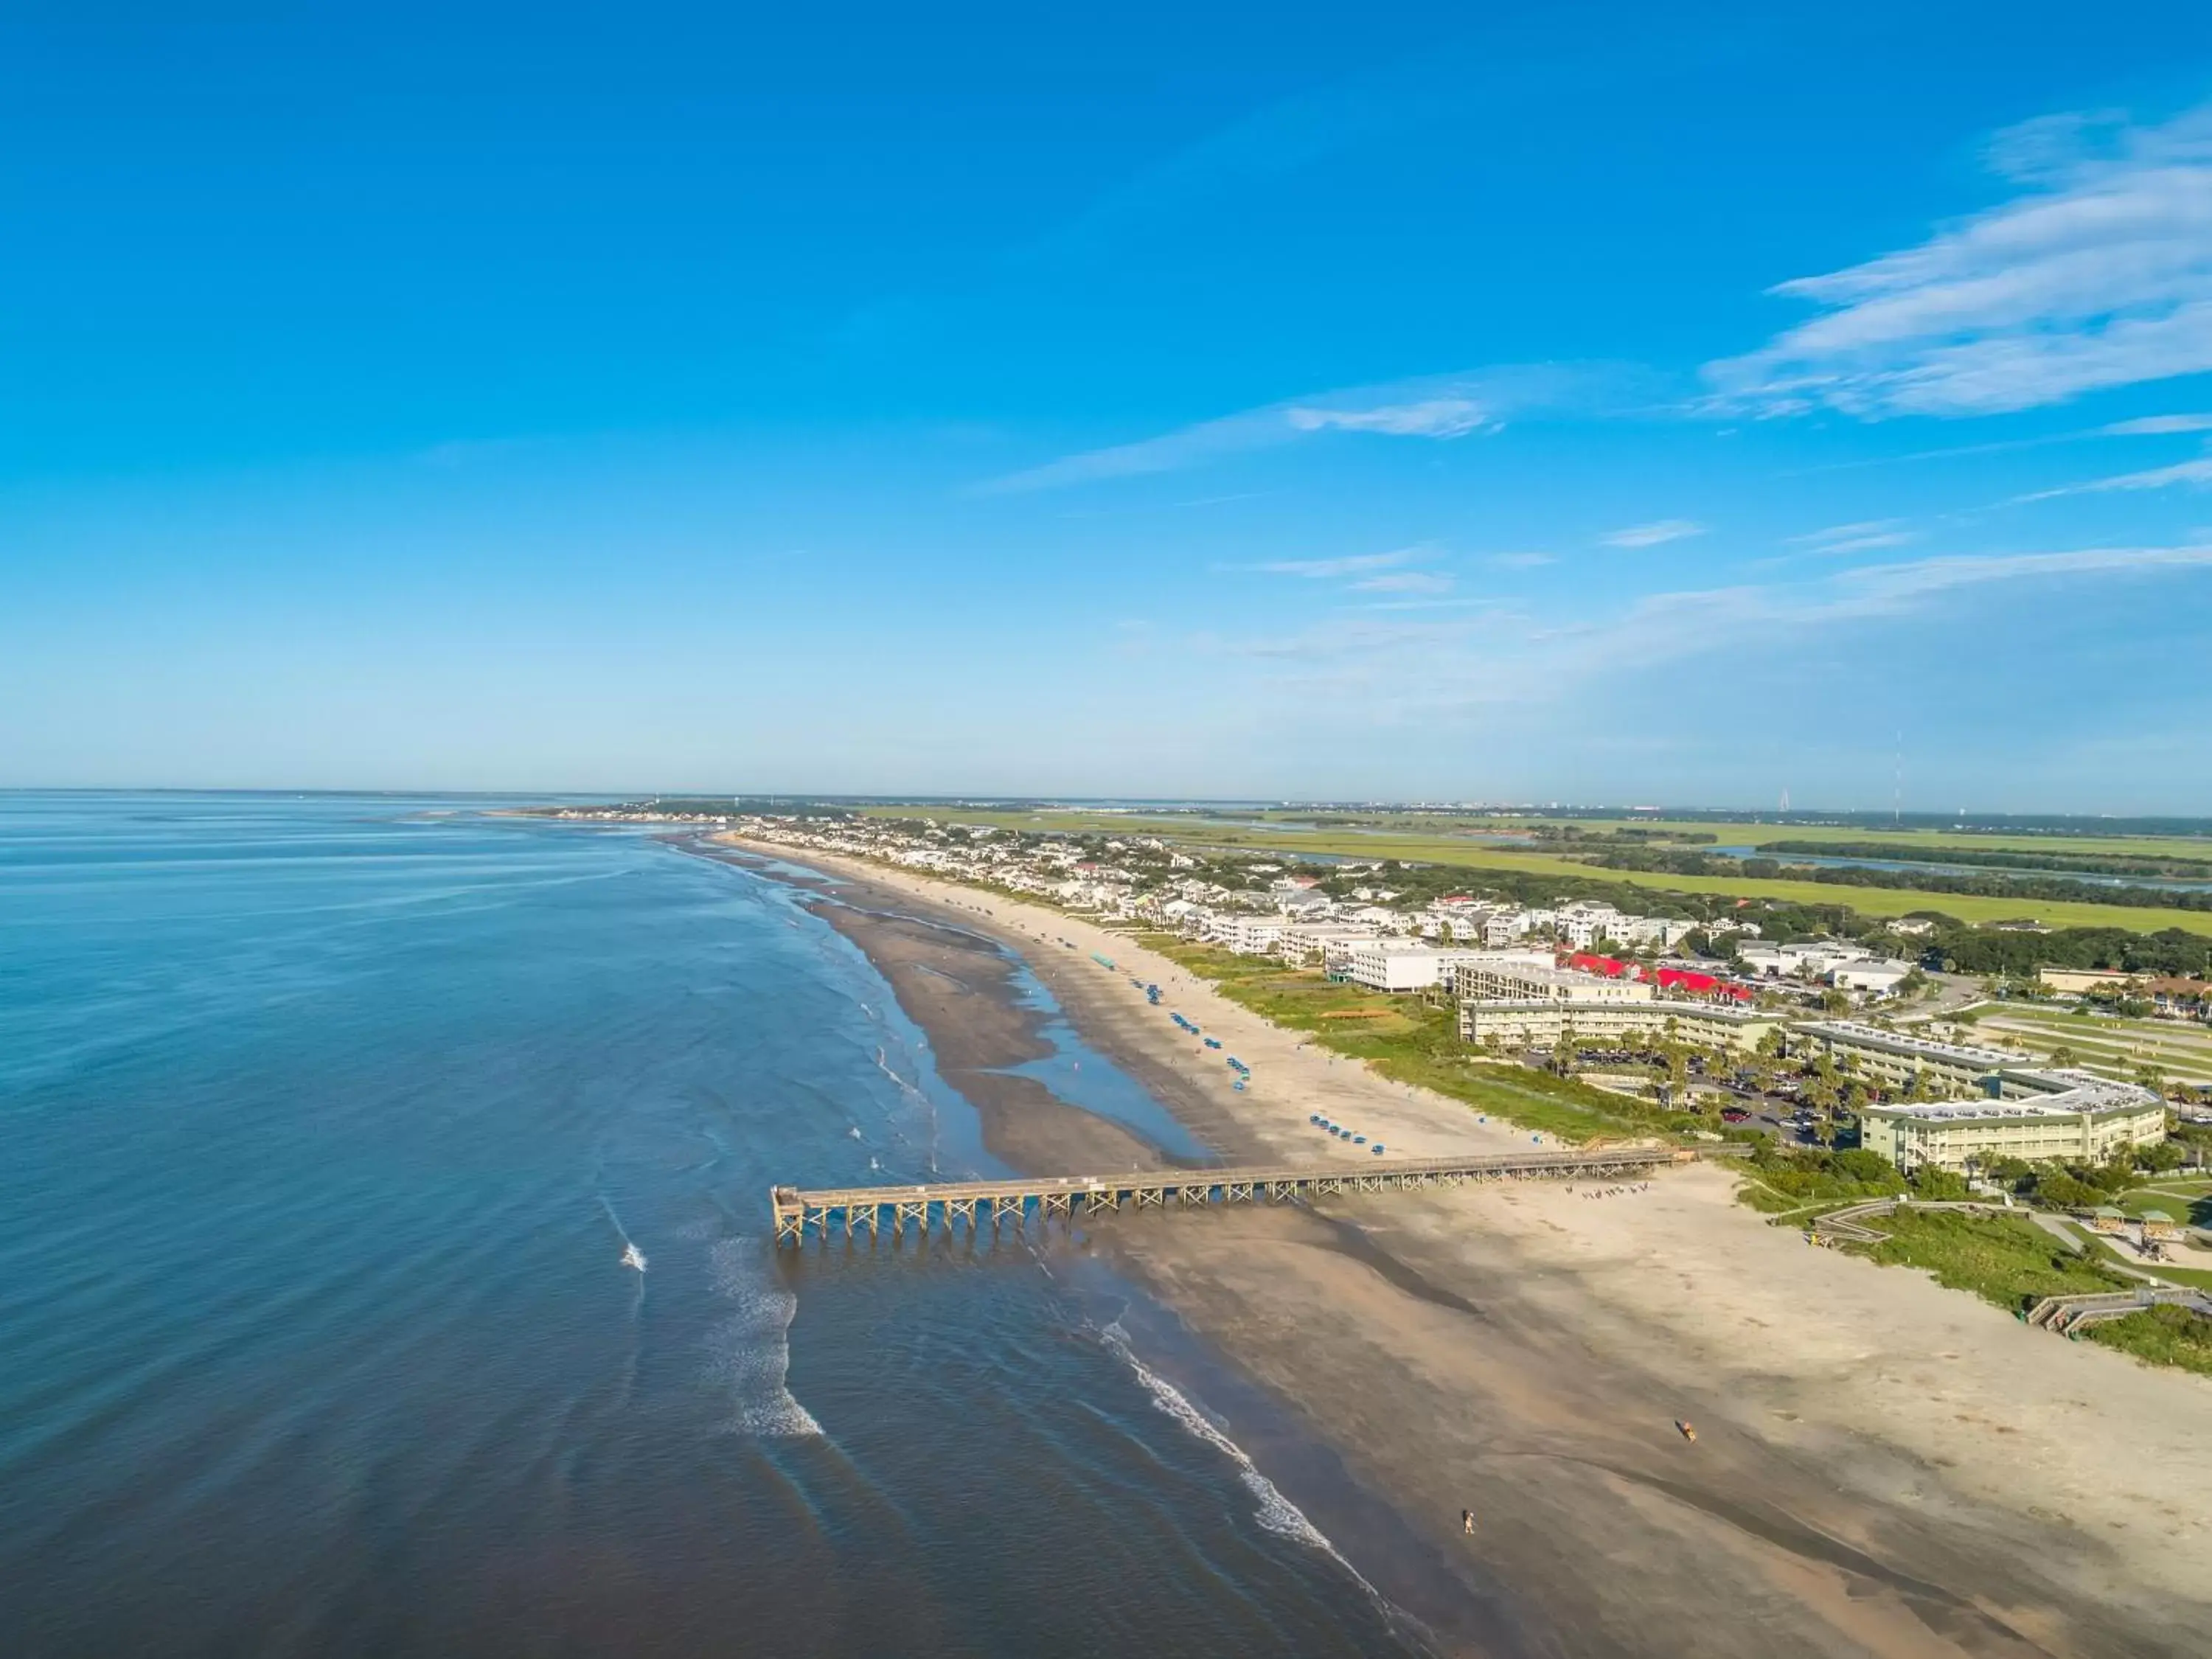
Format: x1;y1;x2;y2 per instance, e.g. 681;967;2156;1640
13;0;2212;814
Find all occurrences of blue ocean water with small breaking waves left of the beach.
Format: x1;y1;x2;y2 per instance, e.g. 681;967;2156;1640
0;794;1394;1657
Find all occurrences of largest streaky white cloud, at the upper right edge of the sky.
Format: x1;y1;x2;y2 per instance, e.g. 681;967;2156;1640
1705;106;2212;418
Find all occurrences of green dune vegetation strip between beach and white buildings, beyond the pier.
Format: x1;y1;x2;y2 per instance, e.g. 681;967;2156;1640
1139;933;1699;1141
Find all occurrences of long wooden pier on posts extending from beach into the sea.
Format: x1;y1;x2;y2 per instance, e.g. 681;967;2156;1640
768;1146;1697;1245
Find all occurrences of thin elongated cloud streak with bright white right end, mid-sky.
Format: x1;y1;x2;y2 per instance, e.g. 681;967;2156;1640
973;363;1648;495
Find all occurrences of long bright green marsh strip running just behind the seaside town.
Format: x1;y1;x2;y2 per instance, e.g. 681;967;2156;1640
869;807;2212;936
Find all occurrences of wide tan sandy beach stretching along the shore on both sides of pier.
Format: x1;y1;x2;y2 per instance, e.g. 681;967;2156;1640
737;843;2212;1659
